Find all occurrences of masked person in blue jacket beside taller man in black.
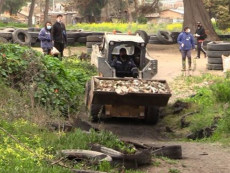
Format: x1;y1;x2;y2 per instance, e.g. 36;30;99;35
38;21;53;55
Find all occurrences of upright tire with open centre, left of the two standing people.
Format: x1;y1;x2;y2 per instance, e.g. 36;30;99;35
12;29;31;45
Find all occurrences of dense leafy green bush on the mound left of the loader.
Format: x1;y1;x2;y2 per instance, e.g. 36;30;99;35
0;44;96;114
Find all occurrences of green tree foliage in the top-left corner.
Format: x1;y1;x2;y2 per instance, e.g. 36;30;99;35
3;0;27;15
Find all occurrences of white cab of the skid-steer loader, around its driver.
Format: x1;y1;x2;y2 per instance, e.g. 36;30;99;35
91;33;157;79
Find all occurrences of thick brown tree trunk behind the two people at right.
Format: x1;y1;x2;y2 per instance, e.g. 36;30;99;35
183;0;219;41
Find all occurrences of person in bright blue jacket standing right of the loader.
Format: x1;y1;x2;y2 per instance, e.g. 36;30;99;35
177;27;195;70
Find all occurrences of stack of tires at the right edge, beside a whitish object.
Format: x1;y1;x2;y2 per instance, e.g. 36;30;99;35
207;42;230;70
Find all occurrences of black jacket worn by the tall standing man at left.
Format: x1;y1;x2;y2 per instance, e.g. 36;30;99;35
52;22;66;44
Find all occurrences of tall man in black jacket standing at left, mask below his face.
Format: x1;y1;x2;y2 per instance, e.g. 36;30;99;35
52;14;67;58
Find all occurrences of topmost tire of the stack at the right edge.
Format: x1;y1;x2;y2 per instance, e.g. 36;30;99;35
207;41;230;51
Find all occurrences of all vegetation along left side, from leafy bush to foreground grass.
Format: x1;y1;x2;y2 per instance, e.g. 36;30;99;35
0;44;141;173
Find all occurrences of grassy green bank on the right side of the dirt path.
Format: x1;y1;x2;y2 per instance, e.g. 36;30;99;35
164;74;230;142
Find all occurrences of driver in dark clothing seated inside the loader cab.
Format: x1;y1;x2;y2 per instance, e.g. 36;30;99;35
111;48;138;78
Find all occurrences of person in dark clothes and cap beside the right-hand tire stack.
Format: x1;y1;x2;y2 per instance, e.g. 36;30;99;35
195;22;207;59
